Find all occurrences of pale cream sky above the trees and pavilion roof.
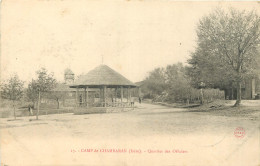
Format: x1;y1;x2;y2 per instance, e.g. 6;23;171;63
0;0;260;83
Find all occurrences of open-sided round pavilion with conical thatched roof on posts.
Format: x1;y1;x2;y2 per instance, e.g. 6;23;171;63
70;65;136;112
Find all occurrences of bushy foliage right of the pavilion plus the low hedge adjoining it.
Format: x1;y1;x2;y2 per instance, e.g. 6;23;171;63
142;63;223;103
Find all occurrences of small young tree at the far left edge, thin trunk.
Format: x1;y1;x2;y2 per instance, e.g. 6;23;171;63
1;75;24;119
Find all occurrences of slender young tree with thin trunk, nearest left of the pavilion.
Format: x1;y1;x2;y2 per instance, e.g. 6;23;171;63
32;68;56;120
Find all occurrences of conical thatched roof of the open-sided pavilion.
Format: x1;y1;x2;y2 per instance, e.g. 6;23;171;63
70;65;136;88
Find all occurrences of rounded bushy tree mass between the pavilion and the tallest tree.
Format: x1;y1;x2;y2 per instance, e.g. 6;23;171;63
142;63;197;103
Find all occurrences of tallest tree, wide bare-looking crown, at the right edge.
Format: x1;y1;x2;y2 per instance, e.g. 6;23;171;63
192;8;260;106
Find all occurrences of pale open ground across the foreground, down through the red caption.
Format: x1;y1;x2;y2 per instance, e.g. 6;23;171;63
0;101;260;166
